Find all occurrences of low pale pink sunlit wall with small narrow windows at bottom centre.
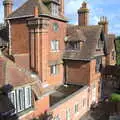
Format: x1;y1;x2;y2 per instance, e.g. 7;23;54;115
49;86;89;120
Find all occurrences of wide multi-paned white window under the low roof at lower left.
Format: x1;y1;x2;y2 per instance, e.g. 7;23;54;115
8;86;32;113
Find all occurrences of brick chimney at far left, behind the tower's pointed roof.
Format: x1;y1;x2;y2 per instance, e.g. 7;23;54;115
3;0;13;18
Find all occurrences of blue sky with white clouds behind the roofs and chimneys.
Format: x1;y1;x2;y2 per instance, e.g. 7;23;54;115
0;0;120;35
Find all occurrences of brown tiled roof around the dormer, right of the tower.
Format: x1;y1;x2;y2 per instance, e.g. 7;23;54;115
63;25;103;60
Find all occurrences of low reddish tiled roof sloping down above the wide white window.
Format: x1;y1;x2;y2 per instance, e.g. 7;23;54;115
0;52;53;98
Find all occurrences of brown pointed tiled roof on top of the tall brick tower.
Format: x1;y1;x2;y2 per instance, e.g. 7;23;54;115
7;0;67;21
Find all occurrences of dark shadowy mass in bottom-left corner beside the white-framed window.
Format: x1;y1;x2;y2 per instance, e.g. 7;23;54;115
0;84;18;120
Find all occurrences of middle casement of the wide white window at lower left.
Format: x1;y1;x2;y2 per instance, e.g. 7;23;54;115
16;88;25;112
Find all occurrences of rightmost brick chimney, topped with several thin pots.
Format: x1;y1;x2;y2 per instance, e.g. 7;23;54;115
98;16;108;34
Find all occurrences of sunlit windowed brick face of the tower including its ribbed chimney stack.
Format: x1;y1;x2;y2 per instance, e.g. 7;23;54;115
29;17;66;85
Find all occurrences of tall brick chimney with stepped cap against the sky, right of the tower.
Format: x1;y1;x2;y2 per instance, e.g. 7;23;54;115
78;2;89;26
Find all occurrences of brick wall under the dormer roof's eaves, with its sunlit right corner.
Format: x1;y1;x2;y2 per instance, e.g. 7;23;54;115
66;59;101;106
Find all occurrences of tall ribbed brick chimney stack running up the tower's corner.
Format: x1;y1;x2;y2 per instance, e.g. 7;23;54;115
27;6;49;82
